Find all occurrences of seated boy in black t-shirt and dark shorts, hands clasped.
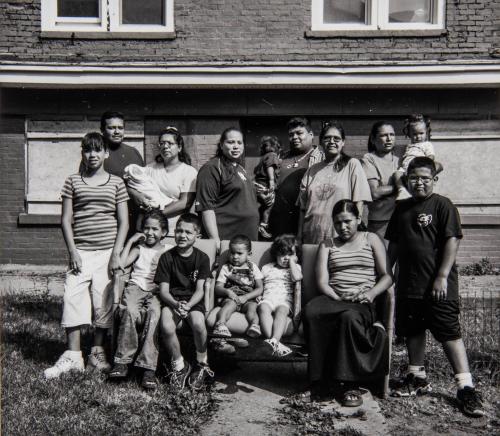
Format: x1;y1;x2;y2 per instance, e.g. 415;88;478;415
154;213;214;389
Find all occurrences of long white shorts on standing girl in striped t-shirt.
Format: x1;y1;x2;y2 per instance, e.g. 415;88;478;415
61;248;114;328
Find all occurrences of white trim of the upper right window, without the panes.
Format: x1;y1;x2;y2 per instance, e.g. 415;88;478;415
311;0;446;31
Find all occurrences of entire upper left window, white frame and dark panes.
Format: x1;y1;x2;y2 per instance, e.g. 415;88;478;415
42;0;174;34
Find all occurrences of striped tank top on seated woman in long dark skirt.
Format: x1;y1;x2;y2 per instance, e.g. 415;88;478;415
328;232;377;295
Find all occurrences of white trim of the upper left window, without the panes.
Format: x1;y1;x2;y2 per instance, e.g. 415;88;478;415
41;0;174;33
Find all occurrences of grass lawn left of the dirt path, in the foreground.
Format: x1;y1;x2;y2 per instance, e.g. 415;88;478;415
1;294;216;435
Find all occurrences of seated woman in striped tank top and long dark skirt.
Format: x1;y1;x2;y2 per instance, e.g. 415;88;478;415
305;200;392;406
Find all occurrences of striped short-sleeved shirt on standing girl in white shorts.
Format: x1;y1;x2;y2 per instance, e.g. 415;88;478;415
61;174;129;250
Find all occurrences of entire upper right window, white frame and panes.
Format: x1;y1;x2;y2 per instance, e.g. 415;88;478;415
311;0;445;31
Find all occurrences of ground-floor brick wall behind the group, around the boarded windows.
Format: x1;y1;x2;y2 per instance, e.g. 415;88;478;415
0;89;500;265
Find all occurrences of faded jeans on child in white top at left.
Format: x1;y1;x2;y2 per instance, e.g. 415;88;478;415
114;283;161;371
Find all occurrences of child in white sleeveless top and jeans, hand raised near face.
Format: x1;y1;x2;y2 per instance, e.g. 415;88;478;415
109;210;173;389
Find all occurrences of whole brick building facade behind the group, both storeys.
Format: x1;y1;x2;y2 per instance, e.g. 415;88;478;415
0;0;500;264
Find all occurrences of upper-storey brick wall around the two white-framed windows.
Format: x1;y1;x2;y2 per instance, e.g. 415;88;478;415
0;0;500;63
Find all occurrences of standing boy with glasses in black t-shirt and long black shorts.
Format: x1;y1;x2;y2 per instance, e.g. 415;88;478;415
385;157;484;416
